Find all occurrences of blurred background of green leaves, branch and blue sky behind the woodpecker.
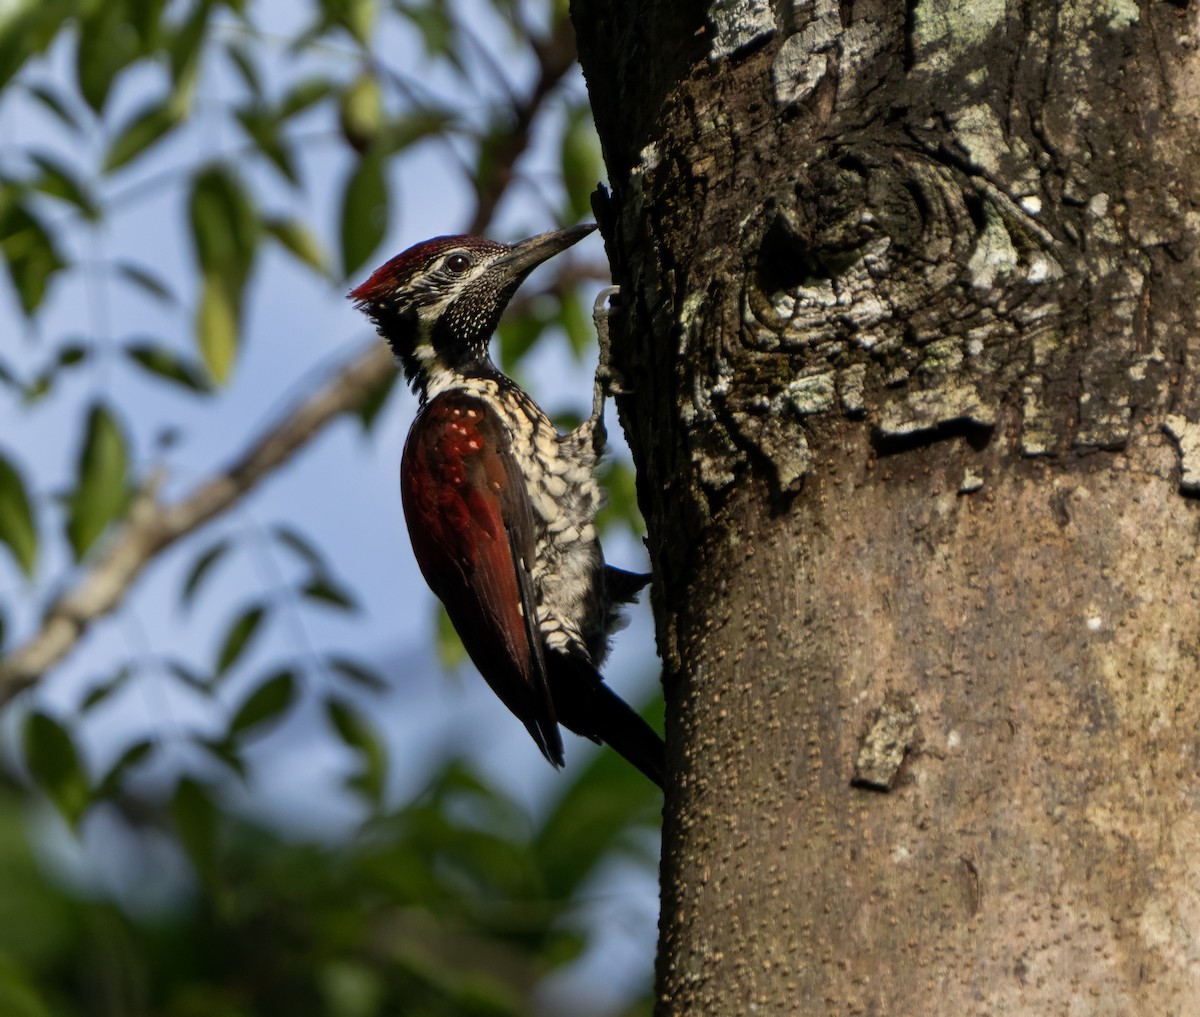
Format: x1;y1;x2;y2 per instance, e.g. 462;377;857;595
0;0;660;1017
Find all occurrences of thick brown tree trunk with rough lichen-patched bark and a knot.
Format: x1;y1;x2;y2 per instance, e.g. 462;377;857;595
574;0;1200;1017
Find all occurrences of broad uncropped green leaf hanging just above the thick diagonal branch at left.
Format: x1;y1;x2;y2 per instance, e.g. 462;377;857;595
67;403;128;560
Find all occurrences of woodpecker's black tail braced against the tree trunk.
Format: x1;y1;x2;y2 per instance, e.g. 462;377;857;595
546;652;666;788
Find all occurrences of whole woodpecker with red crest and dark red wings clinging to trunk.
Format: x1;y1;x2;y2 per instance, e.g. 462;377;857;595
349;223;664;787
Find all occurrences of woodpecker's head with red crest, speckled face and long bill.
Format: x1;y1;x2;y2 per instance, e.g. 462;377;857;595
349;223;595;393
